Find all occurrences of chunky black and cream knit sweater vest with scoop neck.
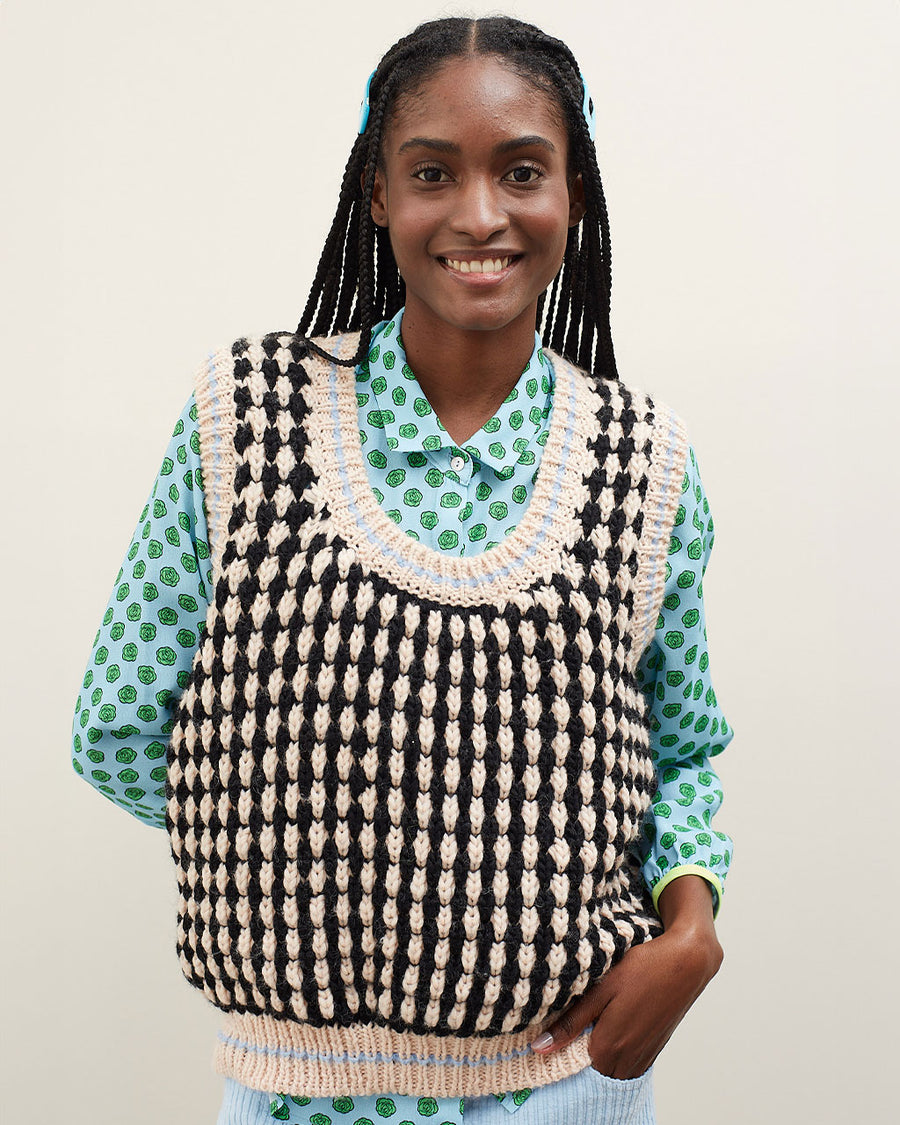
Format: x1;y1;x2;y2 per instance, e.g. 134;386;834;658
167;333;687;1097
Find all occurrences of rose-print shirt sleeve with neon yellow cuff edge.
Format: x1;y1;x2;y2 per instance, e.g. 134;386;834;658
636;449;732;915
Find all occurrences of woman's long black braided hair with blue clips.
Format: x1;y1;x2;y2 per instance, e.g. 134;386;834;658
297;16;618;379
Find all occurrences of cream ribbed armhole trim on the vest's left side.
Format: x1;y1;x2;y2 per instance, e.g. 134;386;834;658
195;348;237;586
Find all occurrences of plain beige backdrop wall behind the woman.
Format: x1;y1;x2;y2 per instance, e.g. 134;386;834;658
0;0;900;1125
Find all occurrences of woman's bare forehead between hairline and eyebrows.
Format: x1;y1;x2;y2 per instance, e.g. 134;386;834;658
387;55;568;153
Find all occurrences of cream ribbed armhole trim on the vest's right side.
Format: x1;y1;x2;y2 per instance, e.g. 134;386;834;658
628;402;687;672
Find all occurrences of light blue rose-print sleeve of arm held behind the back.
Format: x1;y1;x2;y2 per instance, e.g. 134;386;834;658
72;395;212;828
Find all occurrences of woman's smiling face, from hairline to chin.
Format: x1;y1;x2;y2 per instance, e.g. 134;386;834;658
371;55;584;332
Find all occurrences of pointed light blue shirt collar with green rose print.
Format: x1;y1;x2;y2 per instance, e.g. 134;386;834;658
357;309;554;476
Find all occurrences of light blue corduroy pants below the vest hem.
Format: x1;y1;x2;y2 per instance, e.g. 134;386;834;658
216;1067;656;1125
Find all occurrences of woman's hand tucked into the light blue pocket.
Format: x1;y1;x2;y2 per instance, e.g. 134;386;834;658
531;874;723;1079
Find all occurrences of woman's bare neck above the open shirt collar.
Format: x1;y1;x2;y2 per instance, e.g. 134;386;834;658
401;303;537;444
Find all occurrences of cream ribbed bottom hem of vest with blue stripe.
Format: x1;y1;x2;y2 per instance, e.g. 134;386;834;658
214;1013;598;1098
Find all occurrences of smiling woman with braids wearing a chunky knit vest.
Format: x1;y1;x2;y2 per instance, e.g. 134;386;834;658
75;18;730;1125
